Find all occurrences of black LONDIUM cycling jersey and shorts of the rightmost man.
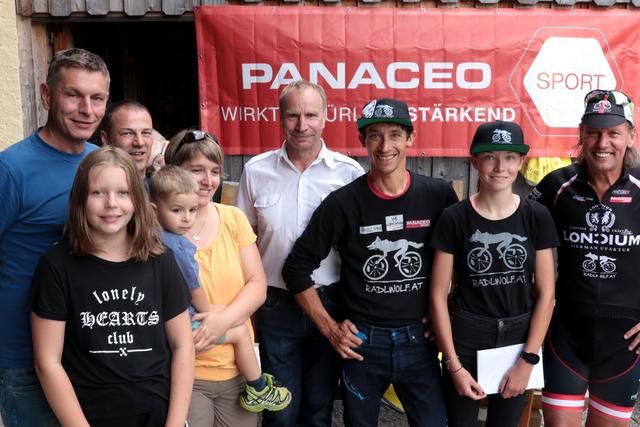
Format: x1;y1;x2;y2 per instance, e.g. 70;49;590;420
530;164;640;421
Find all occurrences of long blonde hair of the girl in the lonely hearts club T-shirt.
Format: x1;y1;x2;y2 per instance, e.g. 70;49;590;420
64;146;164;261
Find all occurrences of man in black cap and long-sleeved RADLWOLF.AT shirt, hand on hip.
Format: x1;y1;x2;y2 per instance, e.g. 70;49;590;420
282;99;457;426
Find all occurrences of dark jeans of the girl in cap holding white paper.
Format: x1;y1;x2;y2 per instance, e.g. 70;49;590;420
444;310;531;427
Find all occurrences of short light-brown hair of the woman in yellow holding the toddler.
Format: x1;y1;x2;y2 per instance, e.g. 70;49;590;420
164;129;224;171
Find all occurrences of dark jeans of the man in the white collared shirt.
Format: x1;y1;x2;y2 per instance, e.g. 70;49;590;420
255;285;339;427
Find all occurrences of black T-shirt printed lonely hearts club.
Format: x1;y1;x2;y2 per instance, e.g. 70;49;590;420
30;241;190;419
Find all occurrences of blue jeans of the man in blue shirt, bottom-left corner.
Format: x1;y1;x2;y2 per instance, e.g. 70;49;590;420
0;368;60;427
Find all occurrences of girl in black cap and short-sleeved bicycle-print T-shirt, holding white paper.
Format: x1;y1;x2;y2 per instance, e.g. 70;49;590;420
430;121;558;427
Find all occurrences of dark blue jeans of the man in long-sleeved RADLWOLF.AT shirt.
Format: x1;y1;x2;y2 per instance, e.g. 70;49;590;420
341;323;446;427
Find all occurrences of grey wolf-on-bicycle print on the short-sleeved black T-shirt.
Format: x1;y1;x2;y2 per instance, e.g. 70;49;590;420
467;230;527;273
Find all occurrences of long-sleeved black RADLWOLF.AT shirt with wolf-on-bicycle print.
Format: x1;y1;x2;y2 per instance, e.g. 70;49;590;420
282;173;457;328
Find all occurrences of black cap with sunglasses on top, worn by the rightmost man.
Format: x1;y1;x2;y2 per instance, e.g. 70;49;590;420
582;89;633;128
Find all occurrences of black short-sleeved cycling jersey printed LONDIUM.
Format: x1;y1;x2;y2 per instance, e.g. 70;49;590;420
530;164;640;320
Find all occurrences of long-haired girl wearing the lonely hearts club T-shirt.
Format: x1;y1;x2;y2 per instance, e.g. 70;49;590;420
30;147;194;427
